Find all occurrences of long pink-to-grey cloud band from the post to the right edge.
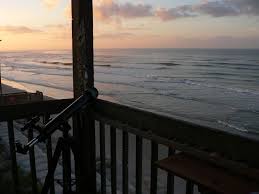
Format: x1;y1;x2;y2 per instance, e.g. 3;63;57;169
94;0;259;23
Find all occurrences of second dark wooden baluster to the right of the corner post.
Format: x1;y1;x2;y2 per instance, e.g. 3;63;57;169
110;126;117;194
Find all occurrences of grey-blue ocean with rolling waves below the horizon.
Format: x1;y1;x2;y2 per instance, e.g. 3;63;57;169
0;49;259;137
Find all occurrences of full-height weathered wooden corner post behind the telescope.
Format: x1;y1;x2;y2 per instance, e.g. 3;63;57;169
72;0;96;194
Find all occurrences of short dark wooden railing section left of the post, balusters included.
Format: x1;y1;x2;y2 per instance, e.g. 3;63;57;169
0;99;73;194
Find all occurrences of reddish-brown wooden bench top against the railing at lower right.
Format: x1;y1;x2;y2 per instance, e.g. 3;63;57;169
156;153;259;194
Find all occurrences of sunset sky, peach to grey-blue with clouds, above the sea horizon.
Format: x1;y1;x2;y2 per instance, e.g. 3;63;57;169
0;0;259;51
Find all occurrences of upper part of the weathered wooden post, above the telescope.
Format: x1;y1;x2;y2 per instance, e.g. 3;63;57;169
72;0;94;97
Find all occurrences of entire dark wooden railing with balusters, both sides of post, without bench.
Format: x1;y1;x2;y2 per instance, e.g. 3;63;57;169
0;99;259;194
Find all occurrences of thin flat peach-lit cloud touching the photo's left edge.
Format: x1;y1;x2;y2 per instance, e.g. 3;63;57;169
0;26;42;34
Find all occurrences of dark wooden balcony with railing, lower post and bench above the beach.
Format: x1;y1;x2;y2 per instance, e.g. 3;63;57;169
0;93;259;194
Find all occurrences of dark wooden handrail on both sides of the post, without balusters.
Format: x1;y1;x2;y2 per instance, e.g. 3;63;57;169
0;96;259;182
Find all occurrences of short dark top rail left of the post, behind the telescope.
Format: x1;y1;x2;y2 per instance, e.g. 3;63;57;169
0;99;73;122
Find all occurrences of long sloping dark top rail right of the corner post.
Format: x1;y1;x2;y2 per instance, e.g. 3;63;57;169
95;100;259;168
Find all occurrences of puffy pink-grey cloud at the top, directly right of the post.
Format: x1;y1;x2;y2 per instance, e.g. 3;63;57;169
94;0;153;21
